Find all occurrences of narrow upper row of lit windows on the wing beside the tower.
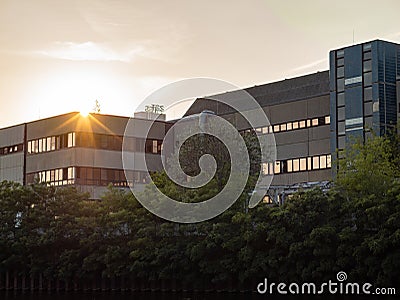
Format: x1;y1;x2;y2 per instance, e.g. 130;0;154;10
244;116;331;134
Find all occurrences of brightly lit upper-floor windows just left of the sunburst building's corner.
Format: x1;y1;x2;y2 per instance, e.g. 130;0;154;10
28;132;75;154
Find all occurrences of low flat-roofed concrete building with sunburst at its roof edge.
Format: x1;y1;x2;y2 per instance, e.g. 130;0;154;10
0;112;168;198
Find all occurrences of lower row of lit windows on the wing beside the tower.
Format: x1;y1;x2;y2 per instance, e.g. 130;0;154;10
261;154;332;175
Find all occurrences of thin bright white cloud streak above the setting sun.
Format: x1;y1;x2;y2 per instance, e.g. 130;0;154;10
35;41;145;62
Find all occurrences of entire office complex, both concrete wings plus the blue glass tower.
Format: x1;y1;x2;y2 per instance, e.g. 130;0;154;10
0;40;400;198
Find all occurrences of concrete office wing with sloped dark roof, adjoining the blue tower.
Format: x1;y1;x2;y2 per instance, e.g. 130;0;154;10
186;71;332;190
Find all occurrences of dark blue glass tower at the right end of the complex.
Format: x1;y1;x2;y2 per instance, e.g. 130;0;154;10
329;40;400;155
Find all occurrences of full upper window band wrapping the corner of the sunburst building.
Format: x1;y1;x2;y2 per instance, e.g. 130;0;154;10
28;132;162;154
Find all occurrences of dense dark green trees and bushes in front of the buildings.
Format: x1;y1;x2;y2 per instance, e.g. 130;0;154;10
0;137;400;289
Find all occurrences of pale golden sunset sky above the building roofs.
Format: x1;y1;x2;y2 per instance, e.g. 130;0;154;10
0;0;400;127
